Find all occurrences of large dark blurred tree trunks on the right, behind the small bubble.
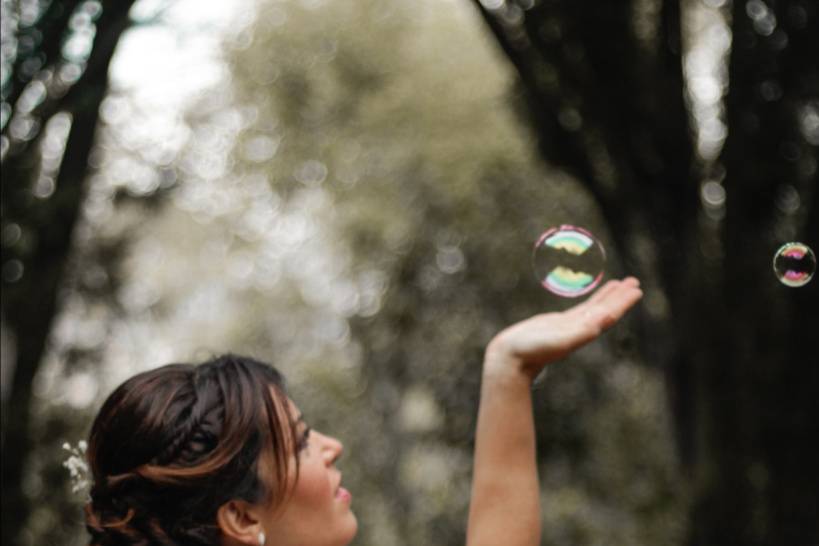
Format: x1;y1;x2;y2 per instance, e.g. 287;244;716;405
475;0;819;545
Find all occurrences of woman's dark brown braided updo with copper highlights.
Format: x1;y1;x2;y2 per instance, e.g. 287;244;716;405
85;355;298;546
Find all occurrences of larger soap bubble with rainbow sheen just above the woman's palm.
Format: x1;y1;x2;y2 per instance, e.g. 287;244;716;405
532;225;606;298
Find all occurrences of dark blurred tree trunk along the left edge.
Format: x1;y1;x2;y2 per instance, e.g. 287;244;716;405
2;0;138;545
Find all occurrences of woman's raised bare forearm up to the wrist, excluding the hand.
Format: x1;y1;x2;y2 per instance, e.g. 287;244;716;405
467;352;540;546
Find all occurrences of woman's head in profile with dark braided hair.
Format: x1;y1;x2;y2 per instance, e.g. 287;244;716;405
86;355;356;546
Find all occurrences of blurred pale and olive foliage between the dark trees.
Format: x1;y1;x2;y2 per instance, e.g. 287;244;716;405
8;0;685;545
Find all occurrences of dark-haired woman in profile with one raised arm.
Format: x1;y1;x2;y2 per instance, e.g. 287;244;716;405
86;278;642;546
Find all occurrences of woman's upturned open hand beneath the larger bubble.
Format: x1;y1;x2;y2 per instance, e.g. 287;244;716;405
484;277;643;380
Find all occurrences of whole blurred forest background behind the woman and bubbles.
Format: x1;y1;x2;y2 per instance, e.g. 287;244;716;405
0;0;819;545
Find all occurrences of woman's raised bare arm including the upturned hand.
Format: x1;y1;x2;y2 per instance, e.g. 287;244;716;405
467;277;642;546
